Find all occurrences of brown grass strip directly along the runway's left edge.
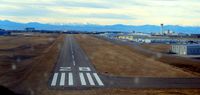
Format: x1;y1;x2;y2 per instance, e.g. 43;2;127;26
13;36;63;95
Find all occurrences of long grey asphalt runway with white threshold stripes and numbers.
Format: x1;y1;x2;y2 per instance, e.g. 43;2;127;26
49;35;104;89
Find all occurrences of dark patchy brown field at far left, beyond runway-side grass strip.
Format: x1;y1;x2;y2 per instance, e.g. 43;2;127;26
0;36;55;87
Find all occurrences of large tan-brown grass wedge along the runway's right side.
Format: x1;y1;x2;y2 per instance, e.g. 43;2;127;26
76;35;193;77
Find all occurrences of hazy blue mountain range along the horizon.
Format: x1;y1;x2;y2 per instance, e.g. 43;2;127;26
0;20;200;34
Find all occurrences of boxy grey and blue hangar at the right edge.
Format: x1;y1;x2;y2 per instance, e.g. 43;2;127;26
171;44;200;55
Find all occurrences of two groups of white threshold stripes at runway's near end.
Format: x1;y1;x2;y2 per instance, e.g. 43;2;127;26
51;72;104;87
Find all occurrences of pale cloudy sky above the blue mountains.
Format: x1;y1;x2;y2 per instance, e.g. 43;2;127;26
0;0;200;26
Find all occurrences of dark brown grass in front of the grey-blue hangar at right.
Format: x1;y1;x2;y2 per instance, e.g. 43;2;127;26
124;45;200;76
